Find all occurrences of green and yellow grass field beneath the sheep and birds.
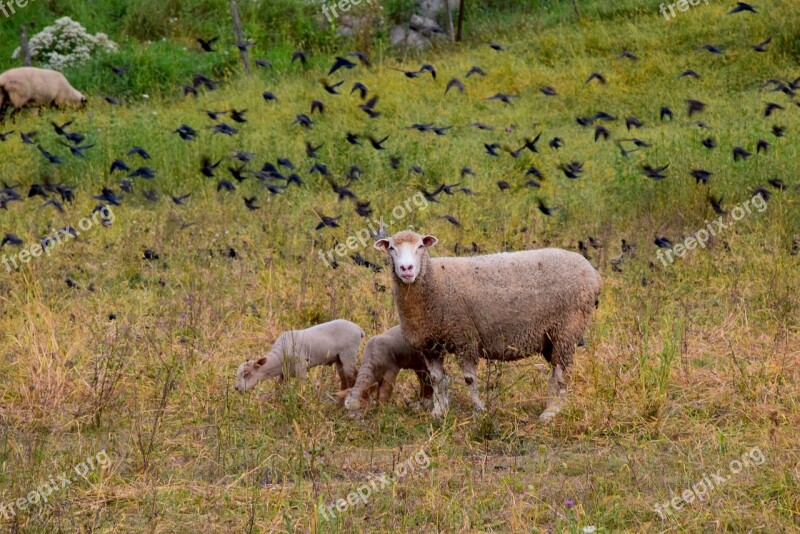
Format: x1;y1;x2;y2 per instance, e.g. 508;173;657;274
0;0;800;533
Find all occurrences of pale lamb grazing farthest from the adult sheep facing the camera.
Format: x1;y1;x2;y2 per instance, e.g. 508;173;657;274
234;319;364;393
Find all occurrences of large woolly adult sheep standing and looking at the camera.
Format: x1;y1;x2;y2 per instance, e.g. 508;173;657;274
375;230;601;420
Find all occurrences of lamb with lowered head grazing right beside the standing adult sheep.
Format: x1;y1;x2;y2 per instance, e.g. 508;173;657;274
337;326;433;412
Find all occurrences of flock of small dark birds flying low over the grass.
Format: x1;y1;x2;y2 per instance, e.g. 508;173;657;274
0;2;800;270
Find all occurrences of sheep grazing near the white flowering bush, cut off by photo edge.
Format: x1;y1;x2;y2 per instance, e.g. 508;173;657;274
0;67;87;124
